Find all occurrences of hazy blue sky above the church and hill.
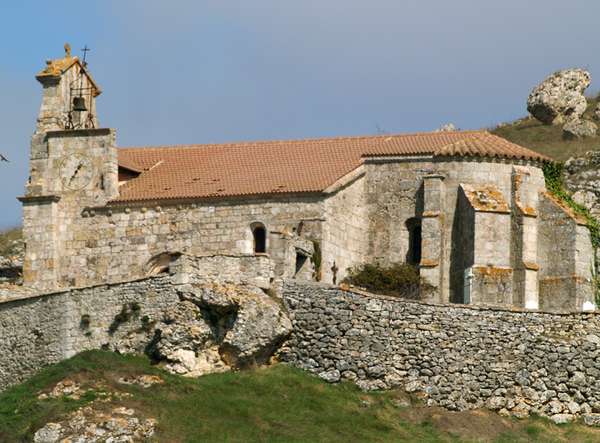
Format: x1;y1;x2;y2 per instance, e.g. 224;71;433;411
0;0;600;228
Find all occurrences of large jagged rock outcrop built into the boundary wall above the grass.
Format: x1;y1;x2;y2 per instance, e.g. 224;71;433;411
113;284;292;377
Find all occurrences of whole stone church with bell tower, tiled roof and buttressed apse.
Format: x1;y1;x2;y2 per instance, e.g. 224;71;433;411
20;46;594;310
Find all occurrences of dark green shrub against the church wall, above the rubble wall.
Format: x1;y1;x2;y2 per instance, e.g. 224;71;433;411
343;263;433;299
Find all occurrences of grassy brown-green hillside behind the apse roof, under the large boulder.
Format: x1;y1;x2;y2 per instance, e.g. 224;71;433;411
491;96;600;162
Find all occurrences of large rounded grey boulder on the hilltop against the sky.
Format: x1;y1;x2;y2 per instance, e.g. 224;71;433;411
527;69;591;125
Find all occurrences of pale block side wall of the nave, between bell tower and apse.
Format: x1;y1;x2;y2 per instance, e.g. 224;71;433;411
52;197;321;287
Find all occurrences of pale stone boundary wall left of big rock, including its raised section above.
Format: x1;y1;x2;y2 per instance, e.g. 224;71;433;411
0;255;272;390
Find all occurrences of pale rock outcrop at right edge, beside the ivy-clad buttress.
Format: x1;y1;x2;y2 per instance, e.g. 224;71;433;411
564;151;600;218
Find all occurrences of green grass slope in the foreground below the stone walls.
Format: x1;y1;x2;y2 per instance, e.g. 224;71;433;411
0;351;600;443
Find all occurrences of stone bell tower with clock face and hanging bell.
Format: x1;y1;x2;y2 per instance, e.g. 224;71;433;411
19;44;118;289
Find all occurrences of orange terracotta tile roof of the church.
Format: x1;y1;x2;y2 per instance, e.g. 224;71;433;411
115;131;549;202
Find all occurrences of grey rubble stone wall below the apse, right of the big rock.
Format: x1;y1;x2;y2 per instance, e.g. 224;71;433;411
281;281;600;421
